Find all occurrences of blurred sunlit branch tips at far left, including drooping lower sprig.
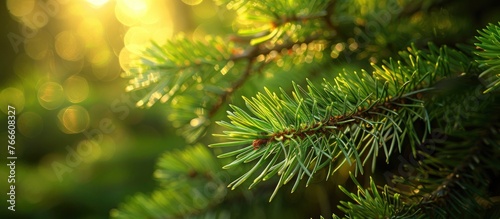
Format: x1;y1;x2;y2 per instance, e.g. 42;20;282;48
125;35;244;142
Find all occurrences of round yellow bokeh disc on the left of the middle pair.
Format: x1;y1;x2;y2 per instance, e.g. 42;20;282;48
38;82;64;110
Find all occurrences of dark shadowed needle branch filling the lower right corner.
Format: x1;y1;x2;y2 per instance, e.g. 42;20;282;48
396;96;500;218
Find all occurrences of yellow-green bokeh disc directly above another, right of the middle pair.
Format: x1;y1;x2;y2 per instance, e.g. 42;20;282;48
64;75;89;103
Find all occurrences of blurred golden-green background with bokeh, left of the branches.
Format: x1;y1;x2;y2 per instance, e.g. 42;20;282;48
0;0;231;218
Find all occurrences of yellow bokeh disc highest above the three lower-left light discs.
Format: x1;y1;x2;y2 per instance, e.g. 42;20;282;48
55;31;85;61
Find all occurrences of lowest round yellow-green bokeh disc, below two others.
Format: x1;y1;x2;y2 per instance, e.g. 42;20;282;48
57;105;90;134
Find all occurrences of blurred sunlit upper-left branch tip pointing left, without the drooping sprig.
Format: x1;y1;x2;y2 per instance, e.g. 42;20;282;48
124;35;234;107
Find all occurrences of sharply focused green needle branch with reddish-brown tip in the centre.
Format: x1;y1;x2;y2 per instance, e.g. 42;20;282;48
210;42;468;198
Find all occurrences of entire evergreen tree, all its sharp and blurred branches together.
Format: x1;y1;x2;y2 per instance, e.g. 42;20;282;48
111;0;500;218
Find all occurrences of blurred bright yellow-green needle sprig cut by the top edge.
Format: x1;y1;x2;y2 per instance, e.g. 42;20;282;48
219;0;329;45
